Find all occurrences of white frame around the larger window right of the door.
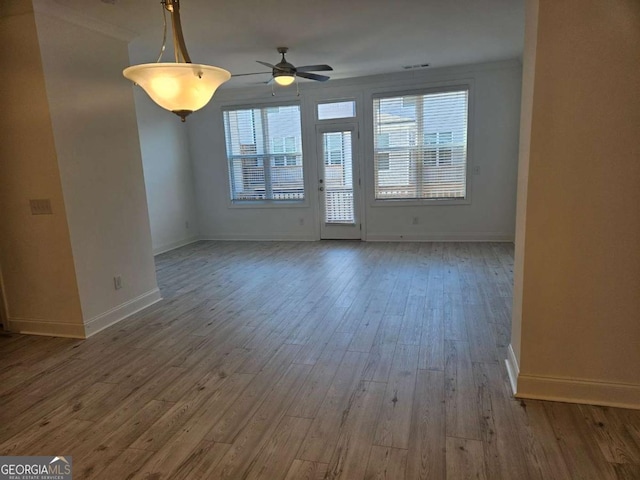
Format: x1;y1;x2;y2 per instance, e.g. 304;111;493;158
366;79;475;207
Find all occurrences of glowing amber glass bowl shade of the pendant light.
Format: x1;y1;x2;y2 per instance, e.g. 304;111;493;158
122;63;231;119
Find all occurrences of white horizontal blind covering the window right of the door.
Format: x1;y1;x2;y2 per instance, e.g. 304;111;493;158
373;89;469;200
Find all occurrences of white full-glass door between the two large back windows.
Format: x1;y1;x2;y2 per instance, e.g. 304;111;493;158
317;124;361;239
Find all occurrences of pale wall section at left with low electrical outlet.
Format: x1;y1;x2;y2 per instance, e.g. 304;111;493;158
36;12;159;334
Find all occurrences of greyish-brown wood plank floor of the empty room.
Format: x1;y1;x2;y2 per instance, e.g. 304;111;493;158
0;241;640;480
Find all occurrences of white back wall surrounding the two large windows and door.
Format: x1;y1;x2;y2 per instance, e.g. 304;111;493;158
187;60;521;241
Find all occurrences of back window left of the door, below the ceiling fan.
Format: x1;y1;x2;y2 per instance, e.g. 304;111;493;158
223;105;304;202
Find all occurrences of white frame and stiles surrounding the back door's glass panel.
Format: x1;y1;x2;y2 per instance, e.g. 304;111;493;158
315;118;366;240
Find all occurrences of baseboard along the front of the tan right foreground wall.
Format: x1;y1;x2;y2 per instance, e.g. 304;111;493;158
516;374;640;410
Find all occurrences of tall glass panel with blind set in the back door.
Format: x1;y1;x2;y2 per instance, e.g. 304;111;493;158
322;130;355;224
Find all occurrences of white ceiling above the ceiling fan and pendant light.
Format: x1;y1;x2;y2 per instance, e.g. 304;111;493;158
50;0;524;88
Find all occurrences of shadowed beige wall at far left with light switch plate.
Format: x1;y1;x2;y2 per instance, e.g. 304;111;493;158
0;0;85;337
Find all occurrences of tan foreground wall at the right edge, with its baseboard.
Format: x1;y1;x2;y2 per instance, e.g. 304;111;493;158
511;0;640;408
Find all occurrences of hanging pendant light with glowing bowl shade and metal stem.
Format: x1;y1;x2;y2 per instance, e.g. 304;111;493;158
122;0;231;122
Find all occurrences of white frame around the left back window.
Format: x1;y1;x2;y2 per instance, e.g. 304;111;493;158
219;99;309;209
